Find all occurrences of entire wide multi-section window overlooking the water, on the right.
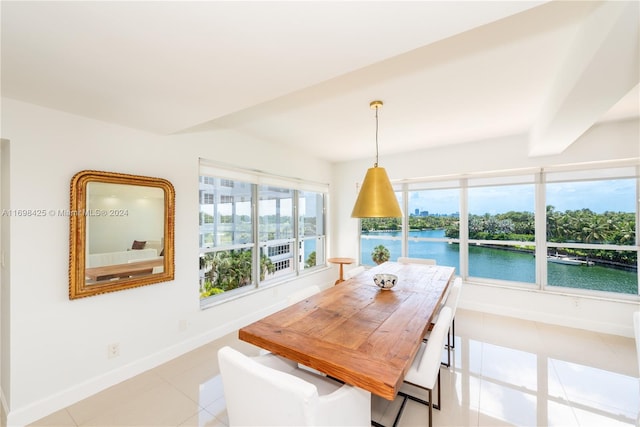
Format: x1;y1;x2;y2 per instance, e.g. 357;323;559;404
360;164;640;298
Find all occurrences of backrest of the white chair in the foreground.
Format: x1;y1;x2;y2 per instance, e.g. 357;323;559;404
218;347;319;426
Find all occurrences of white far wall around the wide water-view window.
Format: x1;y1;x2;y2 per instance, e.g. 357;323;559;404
331;120;640;337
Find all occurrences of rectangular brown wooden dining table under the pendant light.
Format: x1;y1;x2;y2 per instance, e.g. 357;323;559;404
238;262;455;400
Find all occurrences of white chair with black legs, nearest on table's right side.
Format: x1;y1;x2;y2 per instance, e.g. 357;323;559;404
393;307;452;427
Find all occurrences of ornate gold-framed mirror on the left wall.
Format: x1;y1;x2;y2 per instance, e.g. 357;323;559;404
69;170;175;299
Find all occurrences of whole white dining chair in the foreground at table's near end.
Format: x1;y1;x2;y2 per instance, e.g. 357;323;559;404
218;347;371;426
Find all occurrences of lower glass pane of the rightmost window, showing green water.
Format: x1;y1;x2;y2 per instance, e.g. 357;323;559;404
547;248;638;295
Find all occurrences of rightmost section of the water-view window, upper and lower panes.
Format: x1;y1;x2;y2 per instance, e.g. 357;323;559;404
546;168;638;295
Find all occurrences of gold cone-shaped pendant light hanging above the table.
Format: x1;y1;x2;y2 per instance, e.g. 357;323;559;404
351;101;402;218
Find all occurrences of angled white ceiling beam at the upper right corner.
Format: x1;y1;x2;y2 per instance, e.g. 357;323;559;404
529;1;640;156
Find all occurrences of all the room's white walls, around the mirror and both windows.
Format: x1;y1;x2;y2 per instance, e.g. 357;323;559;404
0;99;640;425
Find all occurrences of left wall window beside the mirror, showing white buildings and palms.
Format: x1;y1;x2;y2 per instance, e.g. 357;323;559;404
199;162;328;306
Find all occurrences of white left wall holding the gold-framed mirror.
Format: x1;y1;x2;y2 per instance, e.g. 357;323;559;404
0;99;337;425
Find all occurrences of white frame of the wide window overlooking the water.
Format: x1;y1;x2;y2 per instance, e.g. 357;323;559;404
358;159;640;301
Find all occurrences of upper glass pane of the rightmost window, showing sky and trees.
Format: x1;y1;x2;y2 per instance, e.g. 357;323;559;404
547;179;636;245
